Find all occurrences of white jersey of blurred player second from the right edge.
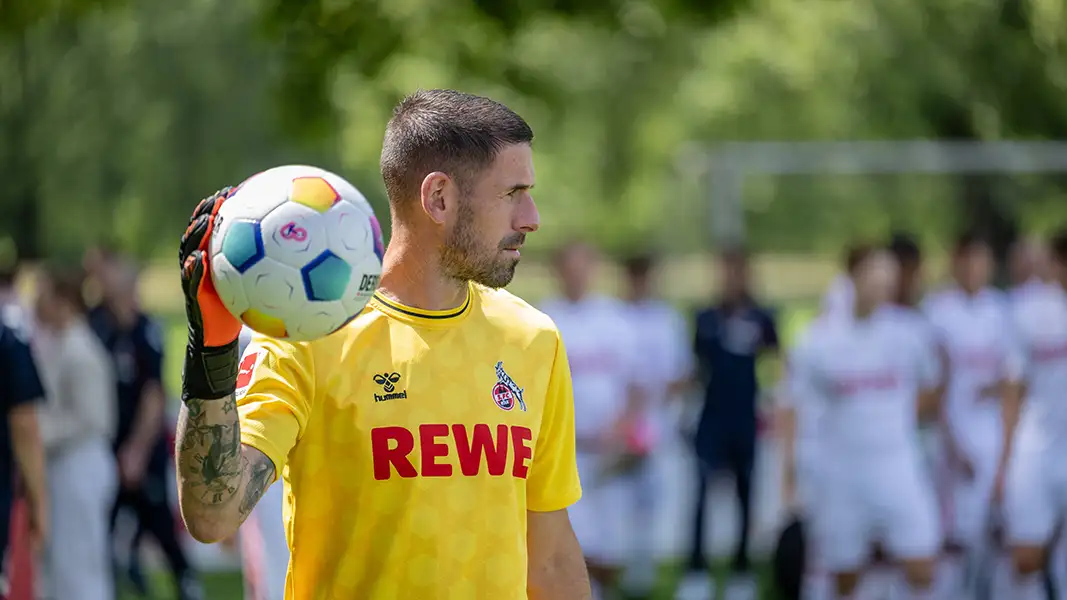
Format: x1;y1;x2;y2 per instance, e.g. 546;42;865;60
923;287;1012;449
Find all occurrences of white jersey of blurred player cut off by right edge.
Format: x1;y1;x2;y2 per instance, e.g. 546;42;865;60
1009;285;1067;442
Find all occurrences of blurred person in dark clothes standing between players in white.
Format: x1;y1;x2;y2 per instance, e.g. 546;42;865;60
679;249;778;600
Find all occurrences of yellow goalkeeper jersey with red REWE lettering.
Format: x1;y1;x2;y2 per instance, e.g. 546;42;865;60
237;284;582;600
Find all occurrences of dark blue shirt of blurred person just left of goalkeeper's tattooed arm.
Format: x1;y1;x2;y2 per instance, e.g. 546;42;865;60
89;306;163;448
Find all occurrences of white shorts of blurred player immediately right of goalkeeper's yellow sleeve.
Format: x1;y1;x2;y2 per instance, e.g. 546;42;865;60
568;454;638;565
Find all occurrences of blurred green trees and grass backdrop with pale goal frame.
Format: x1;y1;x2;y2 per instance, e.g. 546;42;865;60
6;0;1067;600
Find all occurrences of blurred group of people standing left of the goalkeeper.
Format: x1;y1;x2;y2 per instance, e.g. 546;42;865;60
0;248;203;600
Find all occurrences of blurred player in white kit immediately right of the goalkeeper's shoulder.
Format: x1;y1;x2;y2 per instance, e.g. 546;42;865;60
541;242;651;600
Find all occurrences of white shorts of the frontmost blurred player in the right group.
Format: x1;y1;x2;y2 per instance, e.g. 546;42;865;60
811;453;941;572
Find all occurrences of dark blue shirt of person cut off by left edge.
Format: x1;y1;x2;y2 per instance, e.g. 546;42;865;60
0;306;45;525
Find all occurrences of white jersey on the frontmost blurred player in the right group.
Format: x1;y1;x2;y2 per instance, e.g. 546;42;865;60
786;307;939;459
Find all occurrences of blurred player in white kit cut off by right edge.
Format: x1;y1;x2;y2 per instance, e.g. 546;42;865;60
998;232;1067;600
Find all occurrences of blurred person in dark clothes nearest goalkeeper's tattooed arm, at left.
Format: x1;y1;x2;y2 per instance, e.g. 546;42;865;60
90;254;202;599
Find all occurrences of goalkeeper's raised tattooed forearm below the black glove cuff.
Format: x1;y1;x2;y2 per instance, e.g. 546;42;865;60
176;396;274;541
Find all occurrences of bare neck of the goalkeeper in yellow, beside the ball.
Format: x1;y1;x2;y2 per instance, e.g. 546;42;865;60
379;230;469;311
